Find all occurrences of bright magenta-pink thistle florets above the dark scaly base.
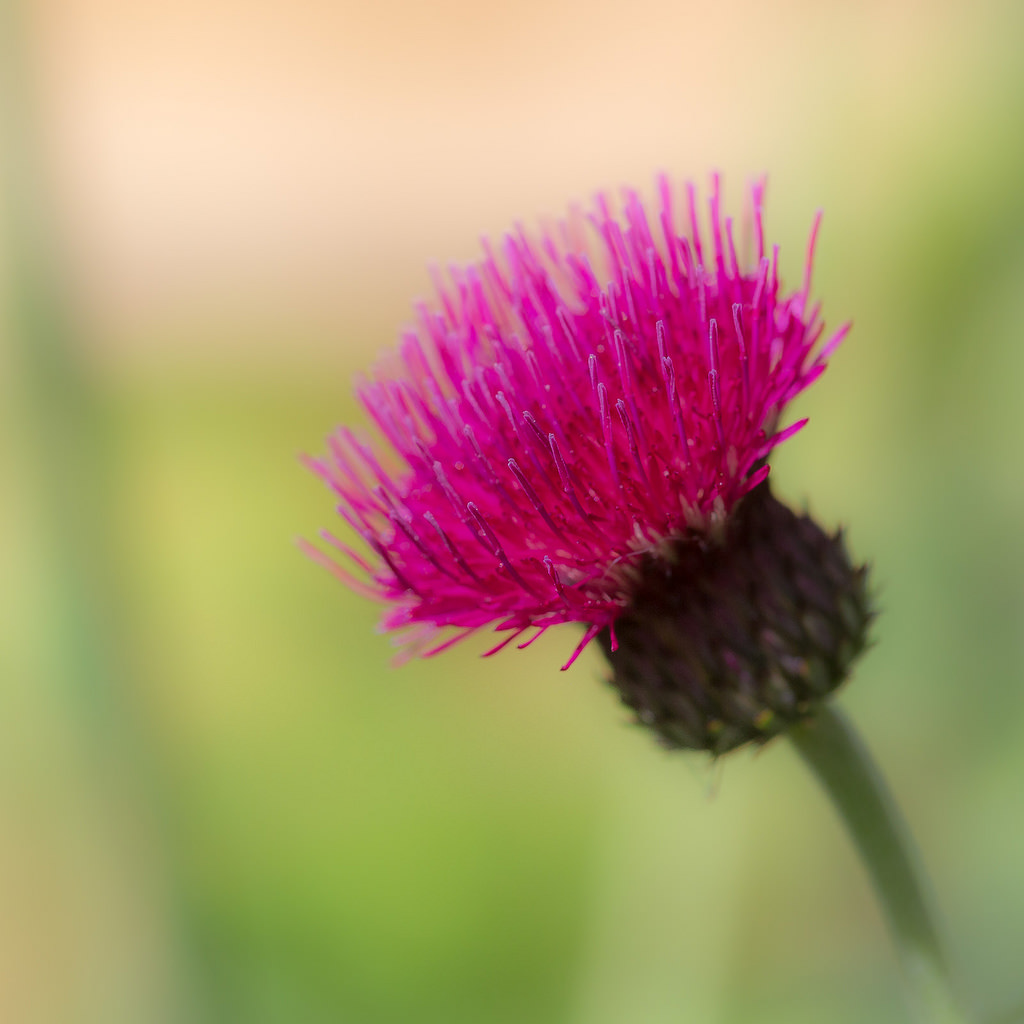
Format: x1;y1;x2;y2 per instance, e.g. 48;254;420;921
303;176;848;668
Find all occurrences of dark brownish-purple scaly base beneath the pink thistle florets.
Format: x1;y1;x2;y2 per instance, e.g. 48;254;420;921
598;481;872;755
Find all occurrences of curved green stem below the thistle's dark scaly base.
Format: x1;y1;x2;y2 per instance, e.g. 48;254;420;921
790;705;967;1024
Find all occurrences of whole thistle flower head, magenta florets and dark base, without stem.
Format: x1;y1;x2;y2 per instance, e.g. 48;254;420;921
304;177;869;751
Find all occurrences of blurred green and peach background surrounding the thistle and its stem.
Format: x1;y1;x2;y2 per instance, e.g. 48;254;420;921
6;0;1024;1024
